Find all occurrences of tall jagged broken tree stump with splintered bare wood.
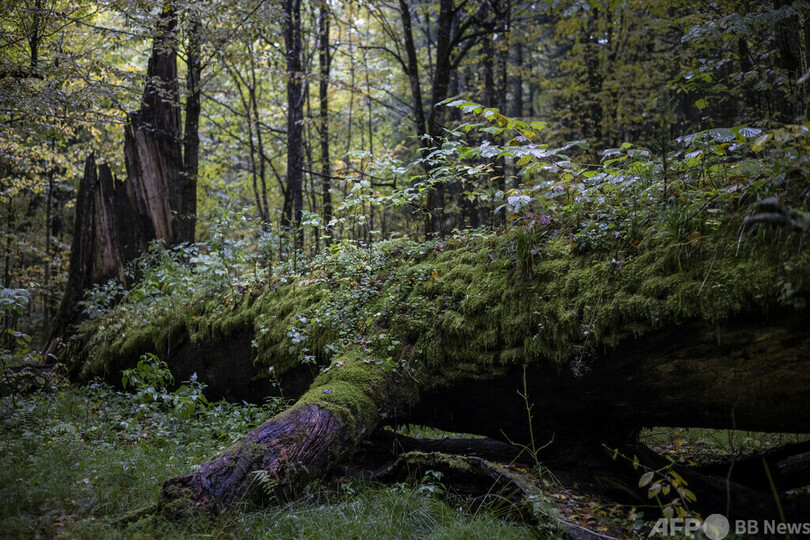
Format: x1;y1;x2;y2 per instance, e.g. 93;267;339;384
45;9;191;356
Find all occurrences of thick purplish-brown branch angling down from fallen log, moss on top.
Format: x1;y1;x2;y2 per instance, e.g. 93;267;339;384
160;353;413;517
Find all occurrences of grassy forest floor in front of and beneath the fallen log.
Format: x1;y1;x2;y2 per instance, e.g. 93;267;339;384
0;372;797;539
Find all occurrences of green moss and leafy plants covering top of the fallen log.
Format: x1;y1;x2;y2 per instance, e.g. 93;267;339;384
72;116;810;385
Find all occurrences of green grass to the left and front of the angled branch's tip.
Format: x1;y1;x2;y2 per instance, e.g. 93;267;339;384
0;383;539;538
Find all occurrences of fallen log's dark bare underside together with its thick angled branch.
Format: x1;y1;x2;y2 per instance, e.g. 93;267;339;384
160;315;810;516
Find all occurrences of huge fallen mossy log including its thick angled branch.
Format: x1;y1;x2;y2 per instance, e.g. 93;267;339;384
71;215;810;515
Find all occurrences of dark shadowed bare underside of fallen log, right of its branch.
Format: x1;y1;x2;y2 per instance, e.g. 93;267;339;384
409;313;810;449
